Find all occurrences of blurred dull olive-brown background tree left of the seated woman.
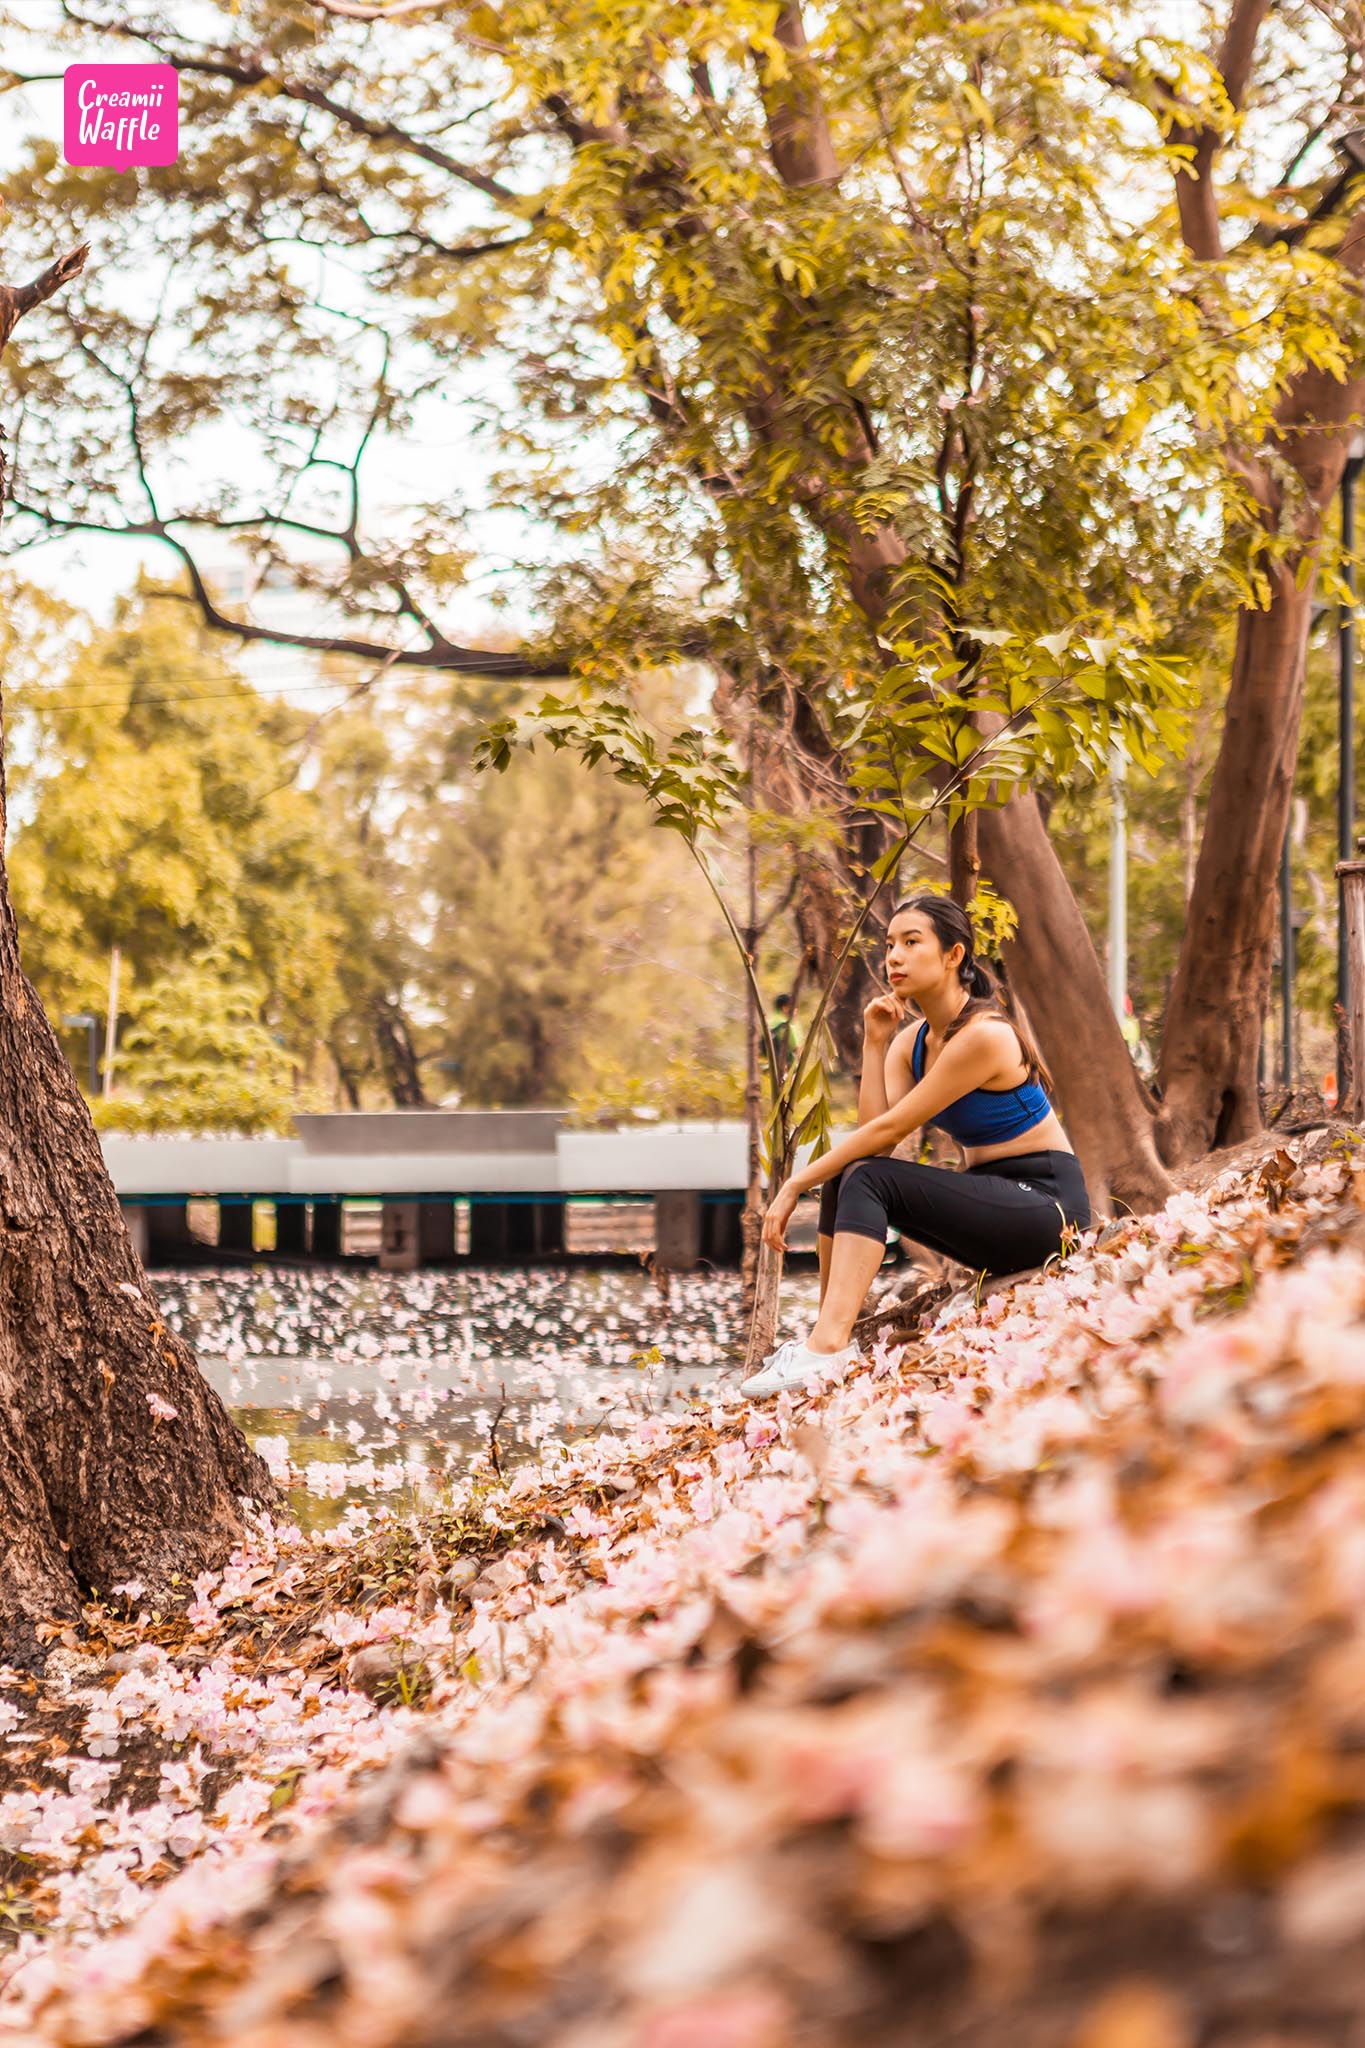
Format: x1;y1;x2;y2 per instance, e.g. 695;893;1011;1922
435;680;743;1120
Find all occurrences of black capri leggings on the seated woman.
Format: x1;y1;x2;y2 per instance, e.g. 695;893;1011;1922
819;1151;1091;1274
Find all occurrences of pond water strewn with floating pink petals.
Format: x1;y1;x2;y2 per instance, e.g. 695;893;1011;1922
153;1266;819;1528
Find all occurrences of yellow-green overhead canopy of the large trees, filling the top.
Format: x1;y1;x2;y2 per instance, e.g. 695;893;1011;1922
10;0;1365;1128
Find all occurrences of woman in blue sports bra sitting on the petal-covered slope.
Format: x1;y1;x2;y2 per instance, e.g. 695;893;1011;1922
743;895;1091;1395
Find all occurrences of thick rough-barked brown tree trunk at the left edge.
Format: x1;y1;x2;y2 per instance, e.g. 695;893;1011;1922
0;248;278;1667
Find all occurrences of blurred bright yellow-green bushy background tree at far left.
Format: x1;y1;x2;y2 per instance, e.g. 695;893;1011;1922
8;577;421;1122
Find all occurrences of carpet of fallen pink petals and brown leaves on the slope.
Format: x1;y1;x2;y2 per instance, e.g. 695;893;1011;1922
0;1143;1365;2048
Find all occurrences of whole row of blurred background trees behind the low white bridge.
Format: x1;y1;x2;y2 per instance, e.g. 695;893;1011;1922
8;588;743;1130
